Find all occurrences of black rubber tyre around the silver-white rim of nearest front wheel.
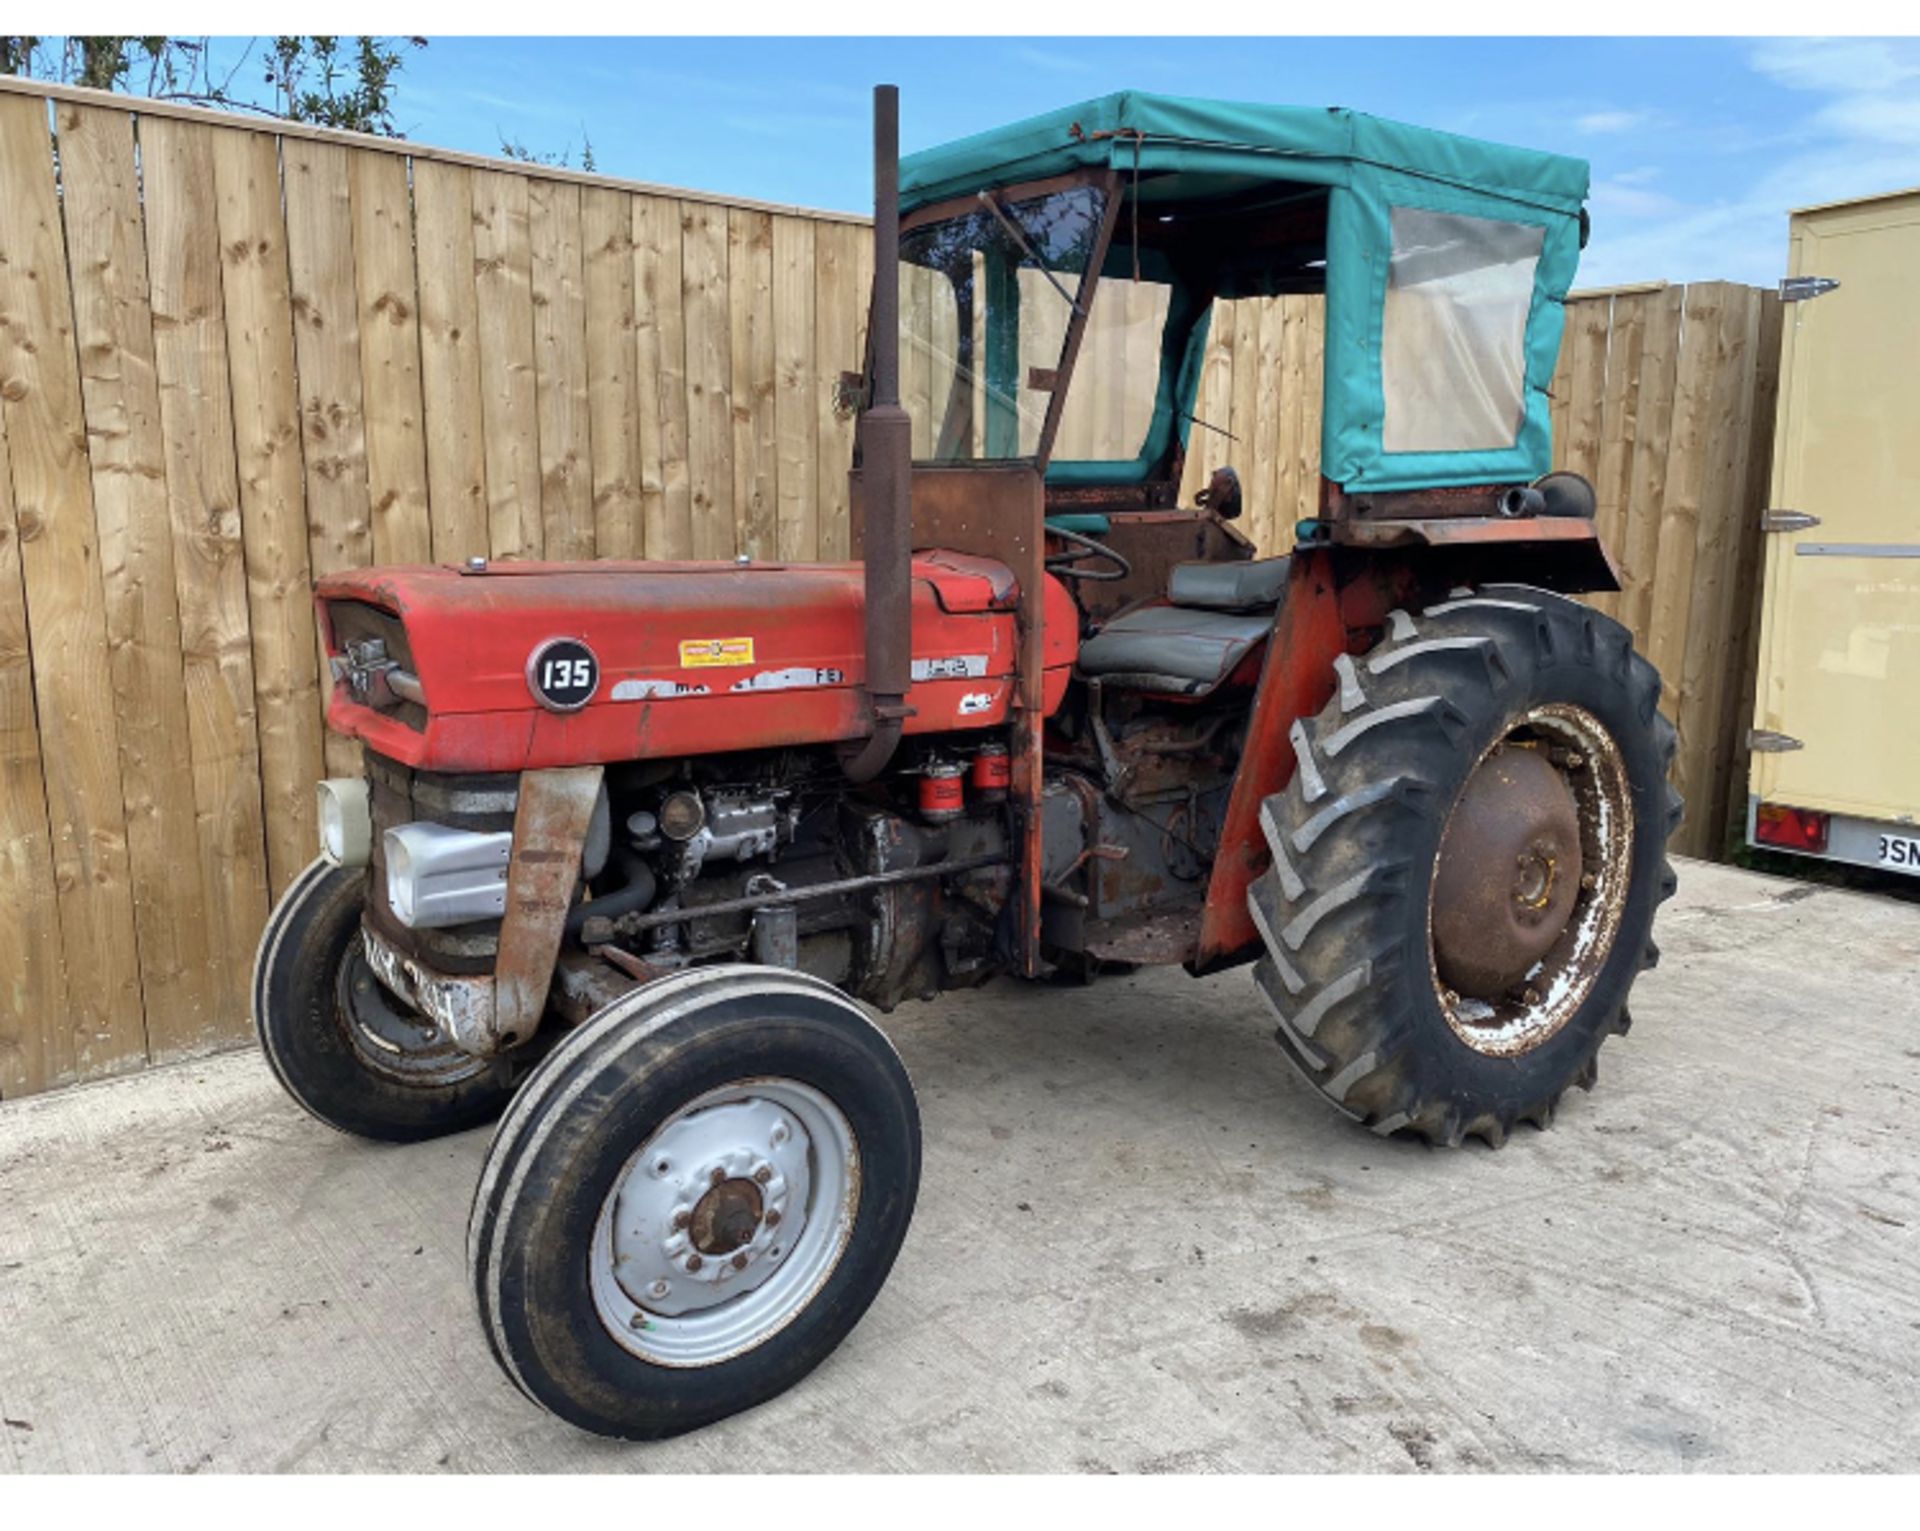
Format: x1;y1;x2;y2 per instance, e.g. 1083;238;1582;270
467;964;920;1441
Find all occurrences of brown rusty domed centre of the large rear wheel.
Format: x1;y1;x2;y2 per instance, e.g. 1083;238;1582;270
1434;745;1580;999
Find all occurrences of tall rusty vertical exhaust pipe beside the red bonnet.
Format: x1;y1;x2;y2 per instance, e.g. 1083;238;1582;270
845;85;914;782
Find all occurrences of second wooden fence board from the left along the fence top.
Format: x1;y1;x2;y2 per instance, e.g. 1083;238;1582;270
57;104;219;1052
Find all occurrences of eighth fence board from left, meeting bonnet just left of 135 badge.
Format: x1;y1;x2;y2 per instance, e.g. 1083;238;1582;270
472;171;545;559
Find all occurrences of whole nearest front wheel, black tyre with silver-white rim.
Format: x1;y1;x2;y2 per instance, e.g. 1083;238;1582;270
467;964;920;1441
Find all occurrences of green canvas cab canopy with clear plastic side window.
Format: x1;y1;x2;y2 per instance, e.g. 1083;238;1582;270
900;90;1588;492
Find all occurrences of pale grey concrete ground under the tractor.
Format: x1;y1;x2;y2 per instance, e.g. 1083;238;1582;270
0;863;1920;1471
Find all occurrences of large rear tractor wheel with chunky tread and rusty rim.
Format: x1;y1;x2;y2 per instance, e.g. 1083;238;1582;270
1248;586;1680;1147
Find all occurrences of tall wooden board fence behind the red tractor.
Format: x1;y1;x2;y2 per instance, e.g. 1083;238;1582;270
0;77;1778;1097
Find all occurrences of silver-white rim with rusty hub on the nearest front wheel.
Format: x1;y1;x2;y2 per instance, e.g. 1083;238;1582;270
589;1078;860;1366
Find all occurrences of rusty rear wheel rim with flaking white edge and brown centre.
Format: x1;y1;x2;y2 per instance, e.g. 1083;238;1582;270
1427;703;1634;1058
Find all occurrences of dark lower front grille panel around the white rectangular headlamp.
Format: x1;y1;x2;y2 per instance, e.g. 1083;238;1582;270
365;749;520;974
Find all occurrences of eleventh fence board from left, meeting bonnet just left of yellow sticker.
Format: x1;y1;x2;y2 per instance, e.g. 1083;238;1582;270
634;196;691;559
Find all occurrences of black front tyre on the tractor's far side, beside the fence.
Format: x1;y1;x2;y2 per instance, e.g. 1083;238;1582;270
253;861;515;1143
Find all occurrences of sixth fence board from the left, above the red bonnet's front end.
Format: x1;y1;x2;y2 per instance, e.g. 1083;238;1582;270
348;150;434;563
